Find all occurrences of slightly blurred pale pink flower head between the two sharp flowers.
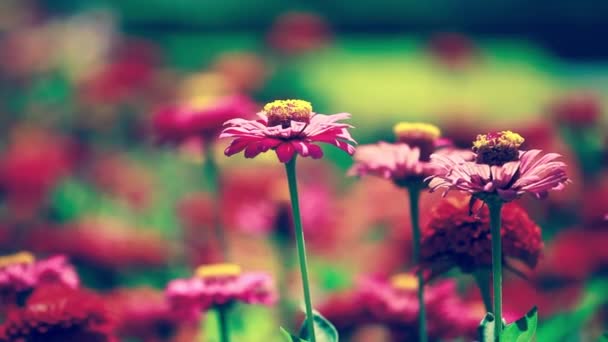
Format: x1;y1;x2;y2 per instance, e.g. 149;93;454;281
349;122;472;186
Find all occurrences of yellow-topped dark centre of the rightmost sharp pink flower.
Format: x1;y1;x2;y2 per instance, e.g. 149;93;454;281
473;131;525;165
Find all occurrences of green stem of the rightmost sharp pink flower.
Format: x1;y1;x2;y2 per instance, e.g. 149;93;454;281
487;201;502;342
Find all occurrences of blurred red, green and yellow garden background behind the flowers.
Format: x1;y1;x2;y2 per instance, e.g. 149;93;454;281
0;0;608;341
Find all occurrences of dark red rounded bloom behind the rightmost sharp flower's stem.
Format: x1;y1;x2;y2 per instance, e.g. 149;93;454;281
421;197;543;274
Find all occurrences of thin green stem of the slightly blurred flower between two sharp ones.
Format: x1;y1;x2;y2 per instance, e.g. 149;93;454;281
408;186;428;342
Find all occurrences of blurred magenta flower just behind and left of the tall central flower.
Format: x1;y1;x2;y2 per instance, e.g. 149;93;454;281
153;95;254;143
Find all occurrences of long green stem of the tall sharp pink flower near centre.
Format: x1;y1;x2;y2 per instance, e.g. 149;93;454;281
285;156;316;342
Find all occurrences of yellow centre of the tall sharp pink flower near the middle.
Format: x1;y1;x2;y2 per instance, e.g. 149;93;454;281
264;100;312;127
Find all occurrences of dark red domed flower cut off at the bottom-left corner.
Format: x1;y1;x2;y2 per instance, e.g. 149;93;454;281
0;286;117;342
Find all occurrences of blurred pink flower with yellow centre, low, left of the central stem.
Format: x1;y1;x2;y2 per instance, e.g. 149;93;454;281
166;264;277;318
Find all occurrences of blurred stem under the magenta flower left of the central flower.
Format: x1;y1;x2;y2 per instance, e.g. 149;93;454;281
204;142;229;261
